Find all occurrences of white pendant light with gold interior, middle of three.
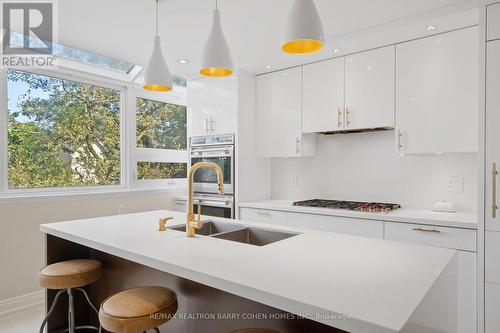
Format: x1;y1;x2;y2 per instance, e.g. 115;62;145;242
200;0;233;77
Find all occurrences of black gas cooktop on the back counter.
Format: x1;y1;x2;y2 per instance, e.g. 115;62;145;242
293;199;401;213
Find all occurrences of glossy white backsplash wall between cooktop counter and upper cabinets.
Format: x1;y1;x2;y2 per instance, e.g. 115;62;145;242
272;131;477;211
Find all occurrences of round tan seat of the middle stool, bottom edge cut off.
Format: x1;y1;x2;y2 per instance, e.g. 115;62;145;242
99;286;177;333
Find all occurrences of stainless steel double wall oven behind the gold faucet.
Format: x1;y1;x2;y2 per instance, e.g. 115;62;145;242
175;134;235;218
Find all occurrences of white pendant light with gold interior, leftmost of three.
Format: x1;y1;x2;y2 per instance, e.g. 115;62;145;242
144;0;173;91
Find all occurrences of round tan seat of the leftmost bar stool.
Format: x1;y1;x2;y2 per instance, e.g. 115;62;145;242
38;259;102;289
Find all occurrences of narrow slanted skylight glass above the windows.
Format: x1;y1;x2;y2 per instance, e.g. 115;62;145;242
10;32;135;74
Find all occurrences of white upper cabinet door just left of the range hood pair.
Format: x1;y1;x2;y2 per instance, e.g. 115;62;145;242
255;67;302;157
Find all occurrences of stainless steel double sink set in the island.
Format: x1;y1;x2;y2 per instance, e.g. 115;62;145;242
170;221;299;246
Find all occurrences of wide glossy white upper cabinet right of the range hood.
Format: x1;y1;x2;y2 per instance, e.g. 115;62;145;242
396;27;479;154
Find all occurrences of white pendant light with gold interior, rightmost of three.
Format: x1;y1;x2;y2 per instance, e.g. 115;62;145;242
281;0;324;54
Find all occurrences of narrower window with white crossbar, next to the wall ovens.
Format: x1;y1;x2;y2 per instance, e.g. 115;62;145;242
132;91;187;185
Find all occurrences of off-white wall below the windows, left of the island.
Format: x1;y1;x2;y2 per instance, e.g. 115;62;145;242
0;191;183;301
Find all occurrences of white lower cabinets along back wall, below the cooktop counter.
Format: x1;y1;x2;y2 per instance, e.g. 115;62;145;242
240;207;478;333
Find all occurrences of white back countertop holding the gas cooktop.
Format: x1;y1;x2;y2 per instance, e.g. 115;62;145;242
239;200;477;229
